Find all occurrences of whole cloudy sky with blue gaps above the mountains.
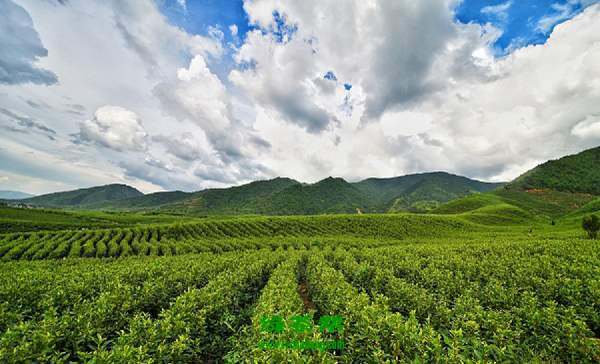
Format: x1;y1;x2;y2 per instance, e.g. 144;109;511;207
0;0;600;194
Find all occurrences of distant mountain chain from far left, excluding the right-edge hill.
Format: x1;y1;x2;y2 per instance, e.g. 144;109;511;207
7;172;503;215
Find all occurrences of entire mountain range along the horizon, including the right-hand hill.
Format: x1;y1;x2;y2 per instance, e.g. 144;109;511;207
5;147;600;215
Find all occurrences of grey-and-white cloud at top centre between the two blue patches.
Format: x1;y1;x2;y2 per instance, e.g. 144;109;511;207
230;0;498;129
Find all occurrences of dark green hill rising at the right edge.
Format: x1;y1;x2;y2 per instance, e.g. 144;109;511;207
505;147;600;195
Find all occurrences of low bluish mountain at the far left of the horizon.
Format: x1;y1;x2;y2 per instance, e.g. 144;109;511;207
20;184;144;207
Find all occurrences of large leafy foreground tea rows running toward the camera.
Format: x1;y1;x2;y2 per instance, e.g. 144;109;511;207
0;237;600;363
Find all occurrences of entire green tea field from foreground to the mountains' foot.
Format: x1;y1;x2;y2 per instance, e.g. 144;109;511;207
0;214;600;363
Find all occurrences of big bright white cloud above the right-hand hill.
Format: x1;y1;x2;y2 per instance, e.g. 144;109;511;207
378;2;600;180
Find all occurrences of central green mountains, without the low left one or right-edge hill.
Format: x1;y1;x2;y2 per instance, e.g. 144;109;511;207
161;172;502;215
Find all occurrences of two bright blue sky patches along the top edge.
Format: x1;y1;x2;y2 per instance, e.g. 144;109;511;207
160;0;600;58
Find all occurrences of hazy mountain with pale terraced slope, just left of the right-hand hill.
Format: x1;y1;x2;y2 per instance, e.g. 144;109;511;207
354;172;504;211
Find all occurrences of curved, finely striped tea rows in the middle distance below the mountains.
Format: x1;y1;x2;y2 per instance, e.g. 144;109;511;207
0;215;473;261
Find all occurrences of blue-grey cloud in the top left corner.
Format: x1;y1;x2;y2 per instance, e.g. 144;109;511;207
0;0;58;85
